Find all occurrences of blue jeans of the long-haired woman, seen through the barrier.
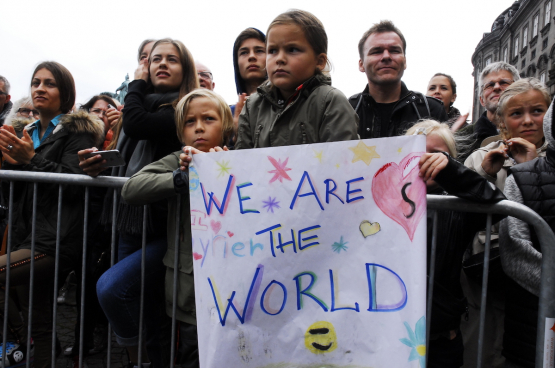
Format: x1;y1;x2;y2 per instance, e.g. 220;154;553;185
96;234;167;368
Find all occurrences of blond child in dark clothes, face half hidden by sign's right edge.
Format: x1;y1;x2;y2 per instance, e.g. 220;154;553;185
407;120;505;368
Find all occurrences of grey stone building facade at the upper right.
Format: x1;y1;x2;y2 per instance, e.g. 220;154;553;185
472;0;555;121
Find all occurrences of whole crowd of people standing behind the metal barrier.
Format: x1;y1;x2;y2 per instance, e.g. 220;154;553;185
0;10;555;368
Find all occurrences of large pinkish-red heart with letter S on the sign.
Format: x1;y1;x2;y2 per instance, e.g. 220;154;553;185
372;153;426;241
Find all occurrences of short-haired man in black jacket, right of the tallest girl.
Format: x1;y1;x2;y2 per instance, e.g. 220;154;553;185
349;20;447;139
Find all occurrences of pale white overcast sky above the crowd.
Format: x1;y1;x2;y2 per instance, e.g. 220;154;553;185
0;0;513;113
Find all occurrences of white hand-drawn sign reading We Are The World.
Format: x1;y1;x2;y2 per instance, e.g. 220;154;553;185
189;136;426;368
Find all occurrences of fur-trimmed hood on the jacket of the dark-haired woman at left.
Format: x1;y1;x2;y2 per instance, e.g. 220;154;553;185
25;110;105;146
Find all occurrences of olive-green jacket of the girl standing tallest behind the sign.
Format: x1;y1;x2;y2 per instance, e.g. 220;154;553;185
235;74;358;149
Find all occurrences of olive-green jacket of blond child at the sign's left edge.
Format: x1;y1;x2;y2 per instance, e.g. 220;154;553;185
121;151;197;325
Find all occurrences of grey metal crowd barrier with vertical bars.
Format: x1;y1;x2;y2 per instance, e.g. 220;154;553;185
0;171;555;368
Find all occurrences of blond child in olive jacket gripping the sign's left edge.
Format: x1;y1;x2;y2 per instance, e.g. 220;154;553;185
122;89;233;367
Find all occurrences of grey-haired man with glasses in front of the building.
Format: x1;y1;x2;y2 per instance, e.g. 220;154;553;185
470;61;520;150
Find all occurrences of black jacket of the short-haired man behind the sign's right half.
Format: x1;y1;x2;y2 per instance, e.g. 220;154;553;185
349;82;447;139
